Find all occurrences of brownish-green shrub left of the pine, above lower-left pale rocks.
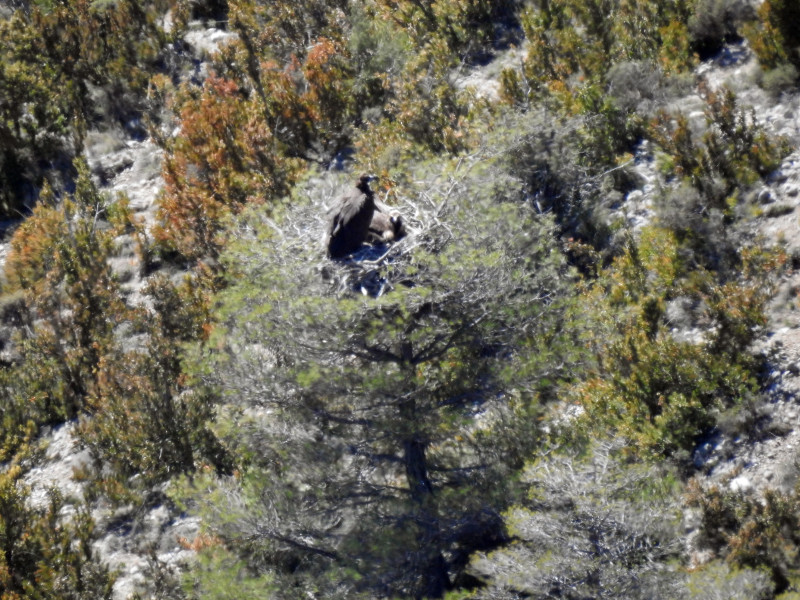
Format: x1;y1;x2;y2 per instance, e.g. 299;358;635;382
79;275;231;490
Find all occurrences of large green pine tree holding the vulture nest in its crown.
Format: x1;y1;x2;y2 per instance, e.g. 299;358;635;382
197;163;580;598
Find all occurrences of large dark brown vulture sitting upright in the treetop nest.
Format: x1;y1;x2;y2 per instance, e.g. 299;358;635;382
327;175;377;258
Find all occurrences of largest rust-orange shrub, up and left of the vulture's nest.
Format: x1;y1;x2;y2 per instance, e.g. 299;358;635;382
154;76;304;261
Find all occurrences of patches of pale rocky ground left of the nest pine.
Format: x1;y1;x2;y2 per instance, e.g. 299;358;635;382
16;21;230;600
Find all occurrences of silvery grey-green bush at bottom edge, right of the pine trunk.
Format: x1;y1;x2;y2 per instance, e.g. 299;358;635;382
466;440;684;600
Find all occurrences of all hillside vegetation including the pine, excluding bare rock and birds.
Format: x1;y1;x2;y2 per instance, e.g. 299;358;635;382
0;0;800;600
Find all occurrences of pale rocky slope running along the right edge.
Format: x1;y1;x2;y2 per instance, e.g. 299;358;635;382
684;45;800;493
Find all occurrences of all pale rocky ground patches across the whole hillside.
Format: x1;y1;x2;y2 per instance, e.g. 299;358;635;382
9;29;800;600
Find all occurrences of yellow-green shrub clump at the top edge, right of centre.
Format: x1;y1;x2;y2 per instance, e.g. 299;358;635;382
510;0;693;170
